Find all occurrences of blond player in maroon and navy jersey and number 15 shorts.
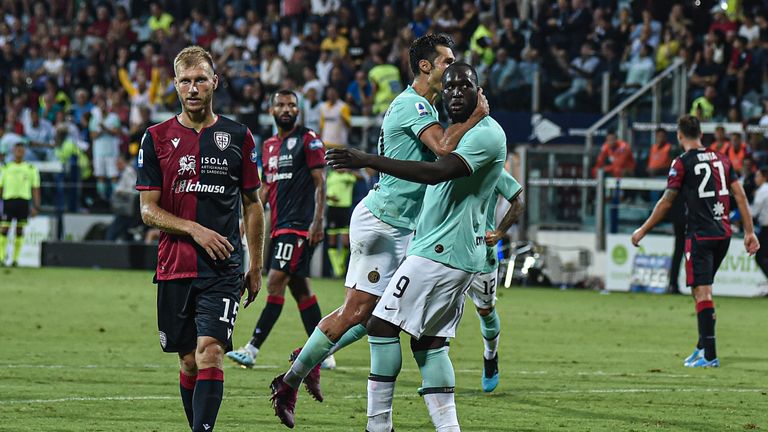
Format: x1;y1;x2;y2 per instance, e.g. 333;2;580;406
136;46;264;431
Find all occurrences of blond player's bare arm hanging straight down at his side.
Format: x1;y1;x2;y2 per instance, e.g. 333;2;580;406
242;190;264;307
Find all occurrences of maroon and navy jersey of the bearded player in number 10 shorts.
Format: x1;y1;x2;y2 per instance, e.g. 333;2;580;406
262;126;325;238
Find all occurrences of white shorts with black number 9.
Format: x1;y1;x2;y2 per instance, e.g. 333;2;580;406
373;255;474;339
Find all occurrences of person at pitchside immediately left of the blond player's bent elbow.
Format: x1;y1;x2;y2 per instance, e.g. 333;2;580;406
107;154;141;241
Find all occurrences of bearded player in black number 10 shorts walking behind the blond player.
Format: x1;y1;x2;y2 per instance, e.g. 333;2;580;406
227;90;325;372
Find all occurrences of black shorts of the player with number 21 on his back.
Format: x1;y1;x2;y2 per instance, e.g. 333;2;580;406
685;236;731;287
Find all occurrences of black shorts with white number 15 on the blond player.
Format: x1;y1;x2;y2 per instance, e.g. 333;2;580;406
157;274;243;354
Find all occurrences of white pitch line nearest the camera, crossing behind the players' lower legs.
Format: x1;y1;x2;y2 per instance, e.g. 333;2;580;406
0;388;768;406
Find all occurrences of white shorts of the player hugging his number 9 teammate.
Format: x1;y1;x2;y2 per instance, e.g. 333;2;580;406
344;201;413;297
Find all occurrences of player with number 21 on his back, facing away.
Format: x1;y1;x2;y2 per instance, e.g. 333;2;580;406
632;115;760;367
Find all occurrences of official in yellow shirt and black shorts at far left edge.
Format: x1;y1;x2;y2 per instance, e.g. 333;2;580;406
0;143;40;267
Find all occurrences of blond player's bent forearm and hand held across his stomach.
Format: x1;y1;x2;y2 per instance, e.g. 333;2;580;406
139;190;235;260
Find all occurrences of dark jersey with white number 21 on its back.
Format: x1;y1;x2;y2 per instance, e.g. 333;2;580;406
667;147;737;240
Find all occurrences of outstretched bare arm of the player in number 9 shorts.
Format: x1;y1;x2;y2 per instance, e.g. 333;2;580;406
325;148;472;184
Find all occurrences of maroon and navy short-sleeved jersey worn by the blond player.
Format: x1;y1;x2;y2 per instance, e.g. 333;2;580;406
136;116;261;280
